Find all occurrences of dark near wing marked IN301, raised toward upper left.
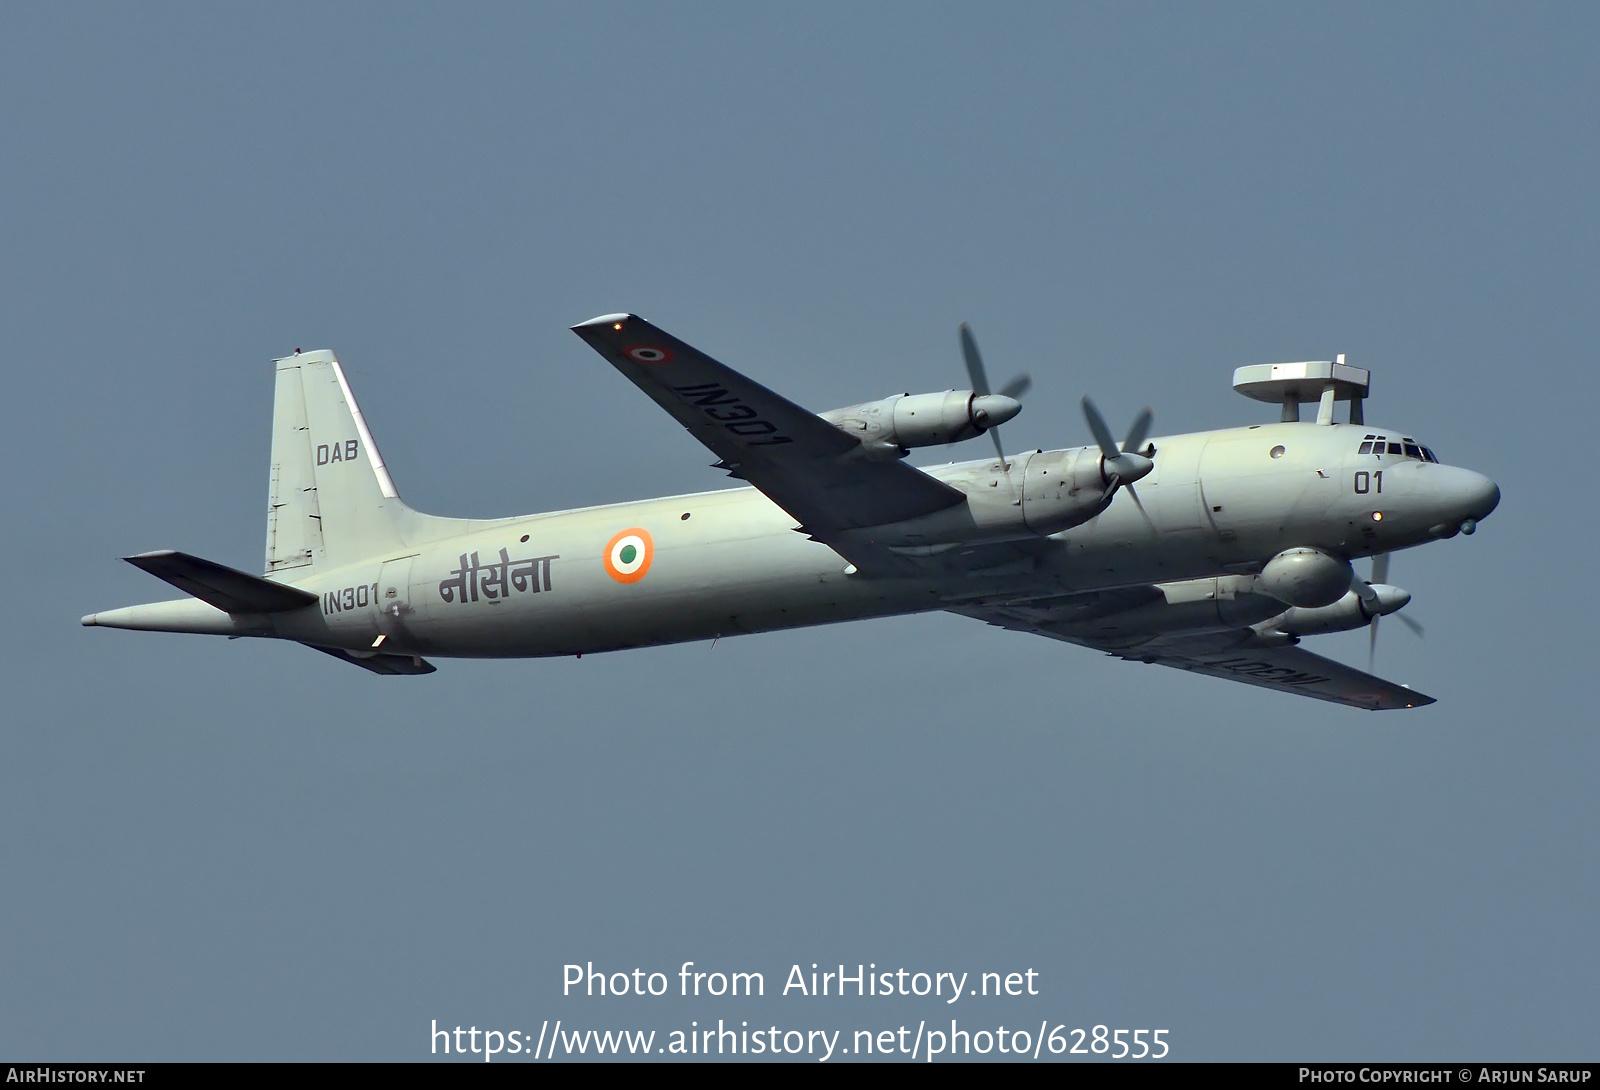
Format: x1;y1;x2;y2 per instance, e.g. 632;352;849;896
573;314;965;540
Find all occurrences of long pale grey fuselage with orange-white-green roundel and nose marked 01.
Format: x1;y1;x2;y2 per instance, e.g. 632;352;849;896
86;423;1499;658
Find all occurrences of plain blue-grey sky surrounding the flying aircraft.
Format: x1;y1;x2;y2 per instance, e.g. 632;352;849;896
0;3;1600;1060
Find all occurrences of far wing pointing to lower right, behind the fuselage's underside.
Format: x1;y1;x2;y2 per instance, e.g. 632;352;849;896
950;587;1435;711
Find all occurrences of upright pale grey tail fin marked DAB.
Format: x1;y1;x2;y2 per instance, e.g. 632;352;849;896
267;351;413;578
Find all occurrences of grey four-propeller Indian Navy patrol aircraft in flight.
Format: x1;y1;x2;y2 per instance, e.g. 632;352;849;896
83;314;1499;709
